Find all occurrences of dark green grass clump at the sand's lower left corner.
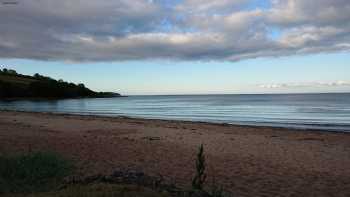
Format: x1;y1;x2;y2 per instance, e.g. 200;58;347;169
0;152;72;194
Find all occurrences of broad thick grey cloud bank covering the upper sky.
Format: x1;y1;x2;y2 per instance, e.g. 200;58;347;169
0;0;350;62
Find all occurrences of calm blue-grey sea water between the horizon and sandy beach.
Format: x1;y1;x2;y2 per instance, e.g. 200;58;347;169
0;93;350;132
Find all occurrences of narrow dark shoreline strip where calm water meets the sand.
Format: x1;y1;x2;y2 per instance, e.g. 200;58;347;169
0;109;350;134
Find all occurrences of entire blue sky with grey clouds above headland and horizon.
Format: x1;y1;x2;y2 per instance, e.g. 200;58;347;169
0;0;350;95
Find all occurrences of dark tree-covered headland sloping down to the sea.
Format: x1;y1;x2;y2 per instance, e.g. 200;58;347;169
0;69;120;98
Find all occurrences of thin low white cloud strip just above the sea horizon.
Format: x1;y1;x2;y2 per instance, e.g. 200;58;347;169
258;81;350;89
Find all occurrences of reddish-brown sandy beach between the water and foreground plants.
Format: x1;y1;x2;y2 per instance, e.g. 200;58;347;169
0;111;350;197
